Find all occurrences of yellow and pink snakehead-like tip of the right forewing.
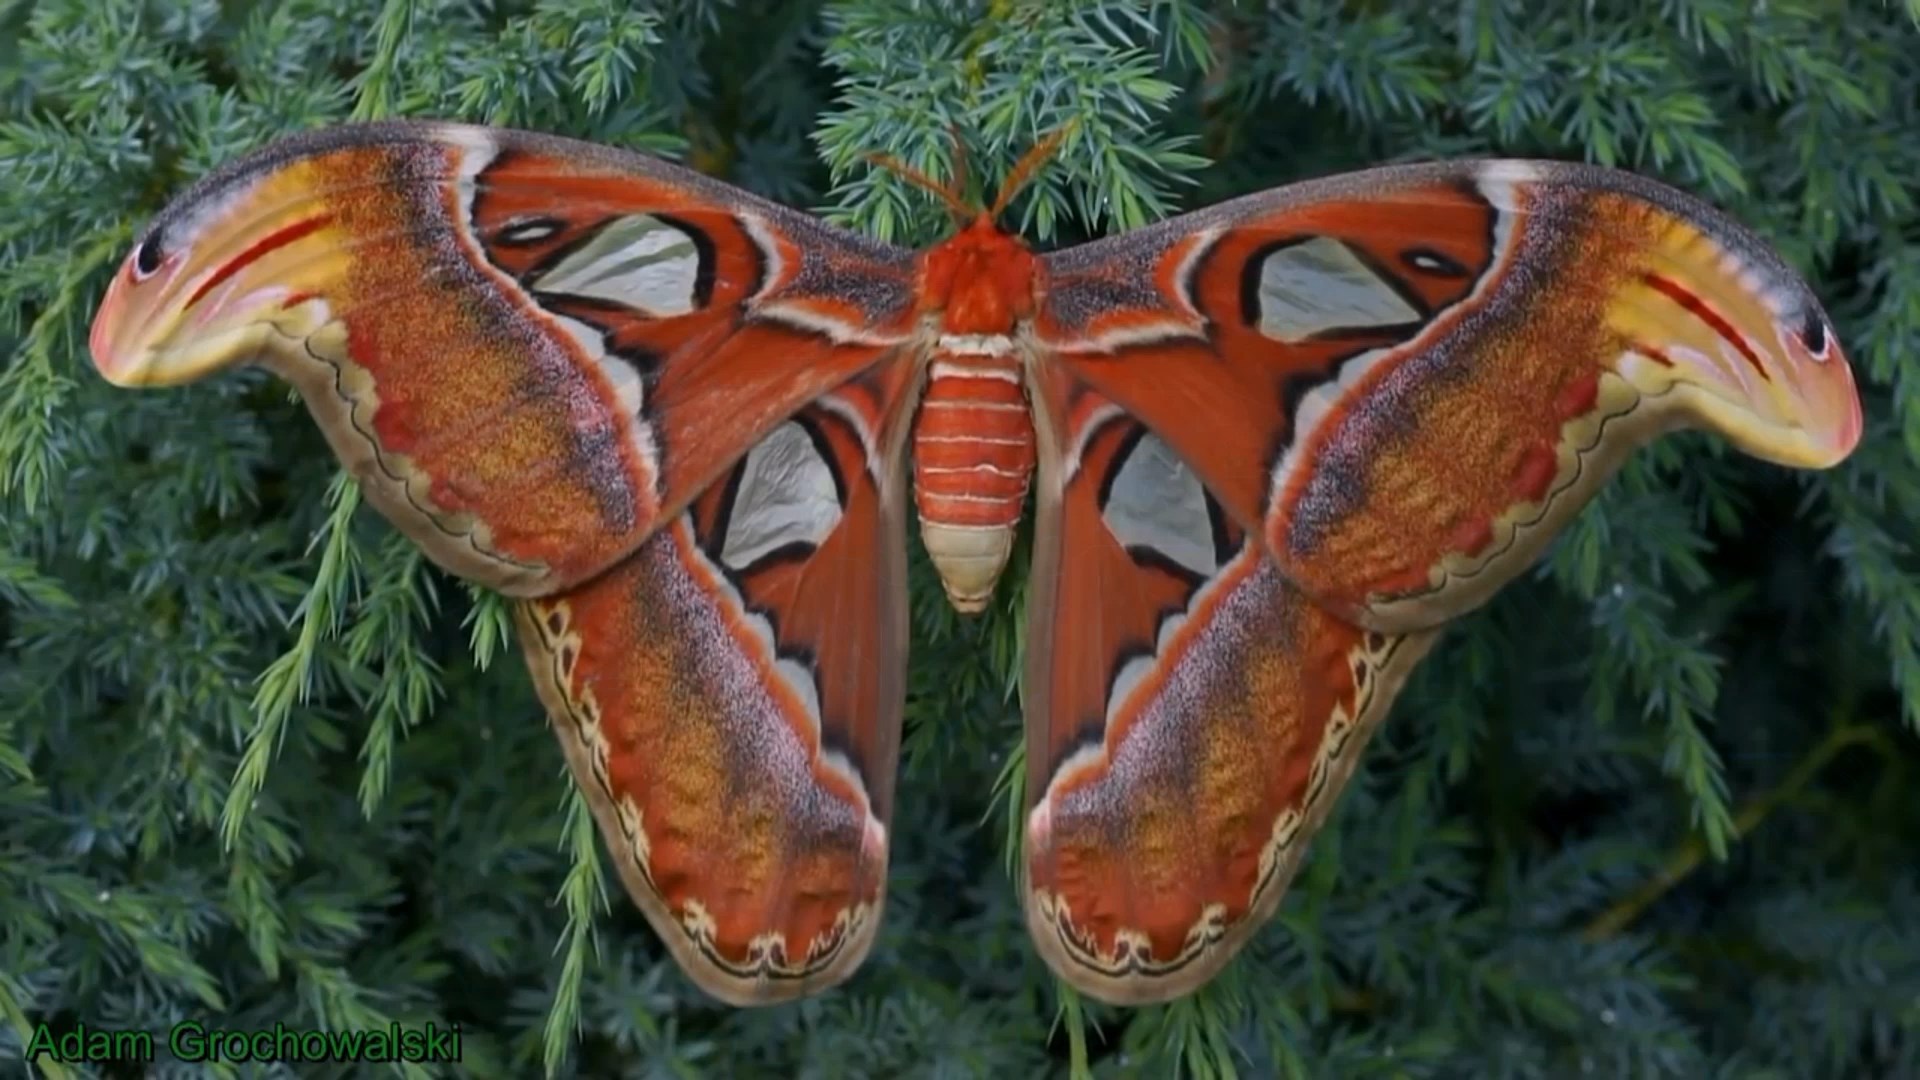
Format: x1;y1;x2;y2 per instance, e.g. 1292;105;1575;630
1615;244;1862;469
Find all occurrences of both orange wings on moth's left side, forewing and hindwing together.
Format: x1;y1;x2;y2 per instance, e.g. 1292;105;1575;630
92;123;920;1003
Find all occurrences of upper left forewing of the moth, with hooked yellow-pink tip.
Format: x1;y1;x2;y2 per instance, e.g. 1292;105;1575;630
92;123;914;596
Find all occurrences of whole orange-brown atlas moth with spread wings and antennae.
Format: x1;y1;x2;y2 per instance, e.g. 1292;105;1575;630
92;123;1860;1005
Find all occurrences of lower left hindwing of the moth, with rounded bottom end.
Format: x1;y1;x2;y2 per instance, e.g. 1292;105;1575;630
518;365;910;1005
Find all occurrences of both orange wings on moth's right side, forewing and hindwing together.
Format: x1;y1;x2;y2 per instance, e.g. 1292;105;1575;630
1025;161;1860;1003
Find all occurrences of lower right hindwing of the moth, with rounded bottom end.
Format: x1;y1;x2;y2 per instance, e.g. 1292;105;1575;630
1025;369;1436;1003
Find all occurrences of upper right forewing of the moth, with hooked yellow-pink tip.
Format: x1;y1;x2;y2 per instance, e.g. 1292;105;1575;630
1035;161;1860;632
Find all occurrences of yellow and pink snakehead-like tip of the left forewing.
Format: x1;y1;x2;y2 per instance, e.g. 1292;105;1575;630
88;167;346;386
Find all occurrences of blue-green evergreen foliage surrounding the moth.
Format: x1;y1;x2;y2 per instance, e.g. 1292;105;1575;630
0;0;1920;1078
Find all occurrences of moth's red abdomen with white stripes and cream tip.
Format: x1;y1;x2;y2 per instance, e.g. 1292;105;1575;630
914;334;1033;611
